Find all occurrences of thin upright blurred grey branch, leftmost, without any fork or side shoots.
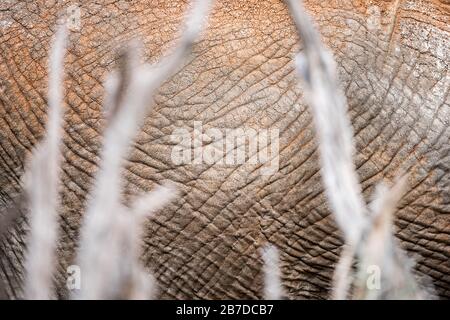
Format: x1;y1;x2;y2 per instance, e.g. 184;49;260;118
25;26;67;299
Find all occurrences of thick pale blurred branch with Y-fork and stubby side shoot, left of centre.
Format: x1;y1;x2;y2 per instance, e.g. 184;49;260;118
77;0;211;299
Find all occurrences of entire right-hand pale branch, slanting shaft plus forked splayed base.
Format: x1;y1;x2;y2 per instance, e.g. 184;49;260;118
286;0;426;299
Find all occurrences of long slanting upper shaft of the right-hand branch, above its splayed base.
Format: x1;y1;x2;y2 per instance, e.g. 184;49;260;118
287;0;367;248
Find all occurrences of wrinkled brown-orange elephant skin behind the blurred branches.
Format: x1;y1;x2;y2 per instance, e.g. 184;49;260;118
0;0;450;298
